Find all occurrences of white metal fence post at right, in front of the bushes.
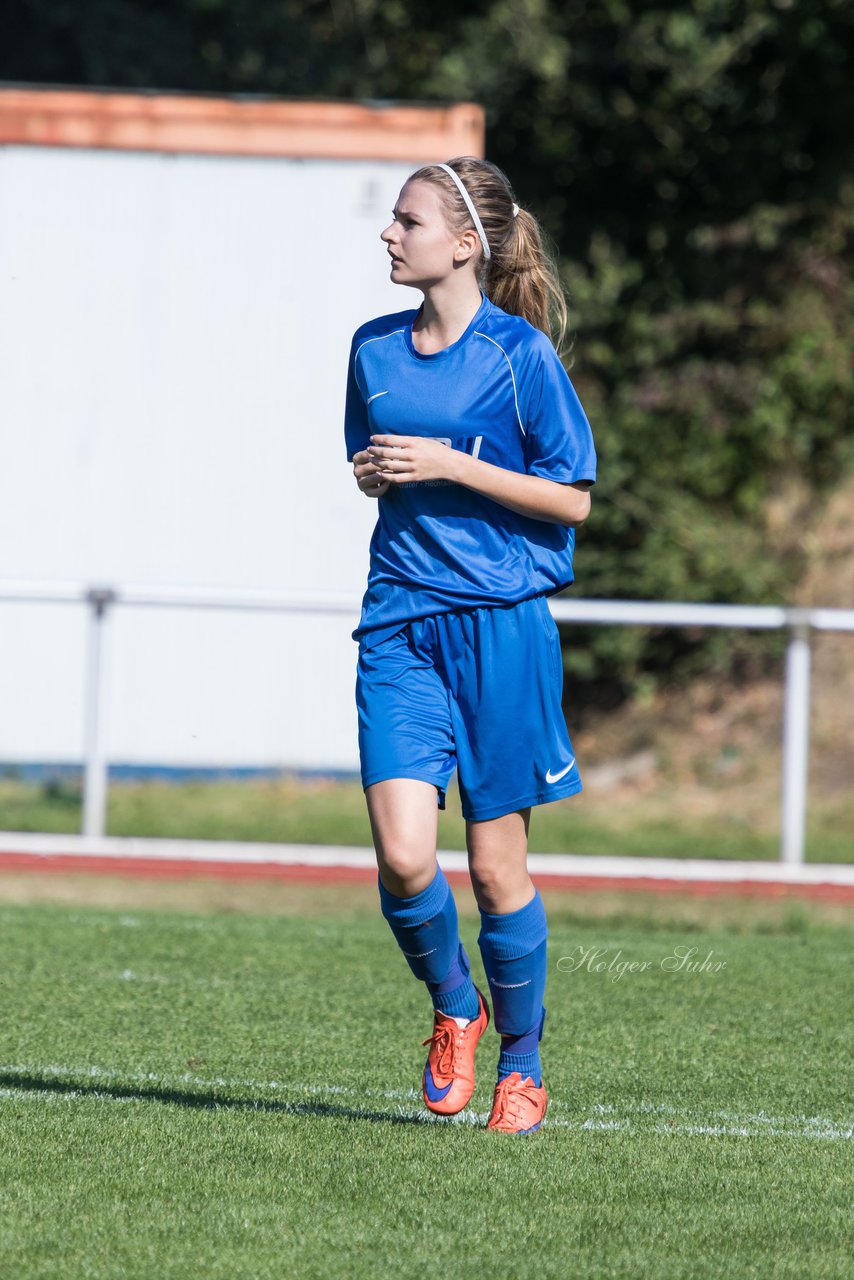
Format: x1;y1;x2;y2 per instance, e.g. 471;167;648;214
780;609;812;867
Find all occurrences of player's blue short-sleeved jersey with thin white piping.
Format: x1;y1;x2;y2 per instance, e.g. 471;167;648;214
344;297;595;646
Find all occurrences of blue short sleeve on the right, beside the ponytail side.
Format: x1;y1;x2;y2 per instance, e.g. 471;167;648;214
522;334;597;484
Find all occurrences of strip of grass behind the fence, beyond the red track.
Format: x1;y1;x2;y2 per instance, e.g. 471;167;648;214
0;777;854;863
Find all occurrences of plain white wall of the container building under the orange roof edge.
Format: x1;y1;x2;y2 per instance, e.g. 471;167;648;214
0;146;417;768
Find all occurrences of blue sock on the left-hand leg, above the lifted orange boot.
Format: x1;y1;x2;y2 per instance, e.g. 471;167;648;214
378;865;480;1018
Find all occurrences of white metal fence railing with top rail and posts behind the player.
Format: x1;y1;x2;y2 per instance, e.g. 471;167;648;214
0;581;854;865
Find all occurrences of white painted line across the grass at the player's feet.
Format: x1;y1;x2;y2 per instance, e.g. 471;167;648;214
0;1064;854;1142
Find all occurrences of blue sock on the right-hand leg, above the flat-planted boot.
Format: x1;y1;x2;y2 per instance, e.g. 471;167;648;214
478;891;548;1085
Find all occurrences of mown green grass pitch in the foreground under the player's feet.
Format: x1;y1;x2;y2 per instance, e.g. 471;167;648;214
0;876;854;1280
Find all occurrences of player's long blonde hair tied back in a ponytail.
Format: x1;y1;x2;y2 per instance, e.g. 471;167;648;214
407;156;567;351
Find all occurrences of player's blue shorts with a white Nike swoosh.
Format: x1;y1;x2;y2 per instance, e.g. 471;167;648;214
356;595;581;822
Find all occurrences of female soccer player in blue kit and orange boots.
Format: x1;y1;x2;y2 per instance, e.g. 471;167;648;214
346;156;595;1133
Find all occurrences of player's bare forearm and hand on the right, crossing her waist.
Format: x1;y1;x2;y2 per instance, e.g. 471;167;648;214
367;435;590;529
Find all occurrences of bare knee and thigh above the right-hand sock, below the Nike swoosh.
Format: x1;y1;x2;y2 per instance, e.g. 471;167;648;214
466;808;534;915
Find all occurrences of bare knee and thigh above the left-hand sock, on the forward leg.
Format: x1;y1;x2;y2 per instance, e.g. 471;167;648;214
365;778;439;897
